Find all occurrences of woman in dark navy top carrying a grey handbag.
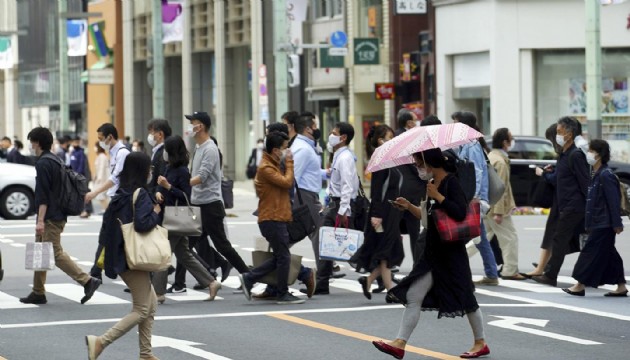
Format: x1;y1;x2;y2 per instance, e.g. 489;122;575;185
153;135;221;304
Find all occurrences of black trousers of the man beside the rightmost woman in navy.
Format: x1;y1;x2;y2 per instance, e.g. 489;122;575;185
545;211;585;279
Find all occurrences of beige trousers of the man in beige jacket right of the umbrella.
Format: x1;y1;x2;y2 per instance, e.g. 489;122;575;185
484;214;518;276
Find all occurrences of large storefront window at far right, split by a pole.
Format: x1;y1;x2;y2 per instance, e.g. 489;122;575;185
536;48;630;146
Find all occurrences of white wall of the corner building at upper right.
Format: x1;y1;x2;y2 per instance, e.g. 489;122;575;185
434;0;630;134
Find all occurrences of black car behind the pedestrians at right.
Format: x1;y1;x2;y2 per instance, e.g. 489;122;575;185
486;135;630;206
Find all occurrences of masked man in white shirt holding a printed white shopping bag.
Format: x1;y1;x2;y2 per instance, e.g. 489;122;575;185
315;122;359;295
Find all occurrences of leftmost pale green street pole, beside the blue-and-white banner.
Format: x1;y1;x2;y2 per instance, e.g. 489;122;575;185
57;0;70;135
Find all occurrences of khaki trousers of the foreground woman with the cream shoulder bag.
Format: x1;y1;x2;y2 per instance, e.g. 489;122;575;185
99;270;157;358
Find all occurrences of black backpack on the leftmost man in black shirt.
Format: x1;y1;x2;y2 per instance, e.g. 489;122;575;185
43;153;90;216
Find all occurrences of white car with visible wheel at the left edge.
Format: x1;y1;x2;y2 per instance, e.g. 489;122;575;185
0;163;35;220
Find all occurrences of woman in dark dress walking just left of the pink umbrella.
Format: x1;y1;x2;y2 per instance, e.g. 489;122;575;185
352;125;405;299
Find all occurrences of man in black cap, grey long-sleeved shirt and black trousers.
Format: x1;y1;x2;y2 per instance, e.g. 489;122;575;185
185;112;249;274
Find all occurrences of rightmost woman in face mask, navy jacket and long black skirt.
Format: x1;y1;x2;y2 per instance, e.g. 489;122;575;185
562;140;628;297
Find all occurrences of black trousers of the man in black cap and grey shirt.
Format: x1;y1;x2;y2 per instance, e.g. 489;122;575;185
196;200;249;274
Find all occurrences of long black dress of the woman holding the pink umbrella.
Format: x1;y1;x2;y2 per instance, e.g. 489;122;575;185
388;175;479;318
